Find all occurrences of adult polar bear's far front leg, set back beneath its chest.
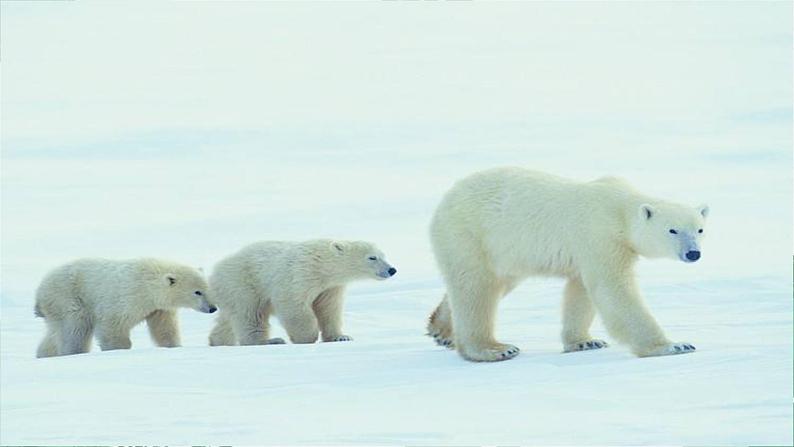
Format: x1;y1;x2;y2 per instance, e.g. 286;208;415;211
562;278;608;352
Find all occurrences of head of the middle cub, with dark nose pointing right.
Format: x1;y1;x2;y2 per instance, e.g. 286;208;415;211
330;241;397;280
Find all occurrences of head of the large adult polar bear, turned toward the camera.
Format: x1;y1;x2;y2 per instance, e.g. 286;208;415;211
630;203;709;262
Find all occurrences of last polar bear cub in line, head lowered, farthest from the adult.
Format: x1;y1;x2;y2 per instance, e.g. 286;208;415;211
35;258;217;358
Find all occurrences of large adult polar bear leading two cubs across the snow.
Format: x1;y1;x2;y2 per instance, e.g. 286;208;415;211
428;168;708;361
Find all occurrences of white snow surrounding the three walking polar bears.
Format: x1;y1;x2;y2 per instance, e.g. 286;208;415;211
0;2;794;445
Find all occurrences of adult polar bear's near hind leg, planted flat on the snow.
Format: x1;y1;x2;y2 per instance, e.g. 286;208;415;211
447;271;519;362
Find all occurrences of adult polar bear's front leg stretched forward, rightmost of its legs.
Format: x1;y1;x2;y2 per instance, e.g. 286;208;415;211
582;267;695;357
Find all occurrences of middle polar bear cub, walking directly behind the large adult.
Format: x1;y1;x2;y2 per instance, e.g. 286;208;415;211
209;239;397;346
